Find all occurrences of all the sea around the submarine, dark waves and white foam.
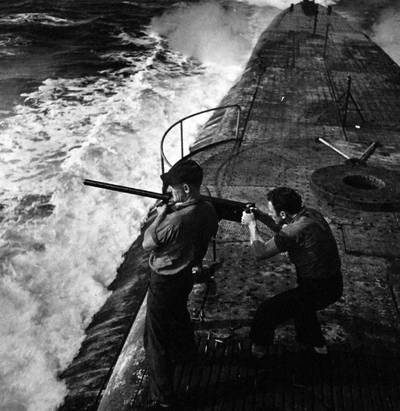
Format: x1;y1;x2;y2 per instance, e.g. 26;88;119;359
0;0;400;411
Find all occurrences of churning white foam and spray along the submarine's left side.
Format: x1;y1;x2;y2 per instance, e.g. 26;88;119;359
0;5;278;411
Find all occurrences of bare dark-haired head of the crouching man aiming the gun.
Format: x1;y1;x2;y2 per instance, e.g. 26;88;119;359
267;187;302;224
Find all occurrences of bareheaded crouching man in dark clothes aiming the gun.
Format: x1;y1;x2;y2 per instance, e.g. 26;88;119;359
242;187;343;358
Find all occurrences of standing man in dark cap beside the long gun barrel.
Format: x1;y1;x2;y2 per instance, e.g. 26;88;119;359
143;160;218;410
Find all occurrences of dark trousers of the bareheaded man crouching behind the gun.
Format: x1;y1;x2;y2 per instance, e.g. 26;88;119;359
250;278;343;347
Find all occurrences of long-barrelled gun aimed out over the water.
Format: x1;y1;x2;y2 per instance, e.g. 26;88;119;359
83;179;277;231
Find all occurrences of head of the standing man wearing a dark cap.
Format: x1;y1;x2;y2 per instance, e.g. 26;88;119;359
161;160;203;202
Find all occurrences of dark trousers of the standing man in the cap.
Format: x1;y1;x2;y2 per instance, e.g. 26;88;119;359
144;271;195;404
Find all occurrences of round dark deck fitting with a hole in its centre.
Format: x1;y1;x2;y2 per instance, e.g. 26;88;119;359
311;164;400;211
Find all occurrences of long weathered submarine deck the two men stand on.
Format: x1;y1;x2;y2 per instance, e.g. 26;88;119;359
57;2;400;411
